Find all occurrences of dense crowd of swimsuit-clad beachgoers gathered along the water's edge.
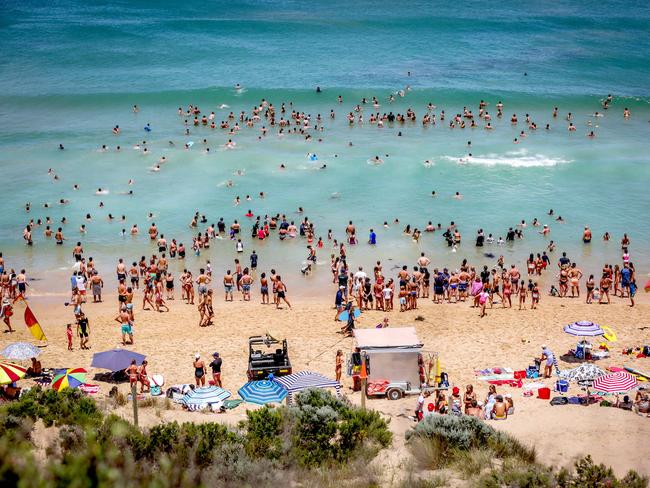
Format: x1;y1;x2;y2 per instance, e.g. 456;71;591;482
0;194;637;348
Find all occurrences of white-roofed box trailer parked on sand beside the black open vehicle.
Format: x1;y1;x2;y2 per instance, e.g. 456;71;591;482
348;327;440;400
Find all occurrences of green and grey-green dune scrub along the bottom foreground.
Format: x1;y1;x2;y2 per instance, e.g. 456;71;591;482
0;388;648;488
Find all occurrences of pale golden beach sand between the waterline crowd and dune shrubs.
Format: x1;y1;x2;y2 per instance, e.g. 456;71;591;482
6;295;650;474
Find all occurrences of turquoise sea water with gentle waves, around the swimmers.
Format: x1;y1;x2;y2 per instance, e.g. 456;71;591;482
0;1;650;291
